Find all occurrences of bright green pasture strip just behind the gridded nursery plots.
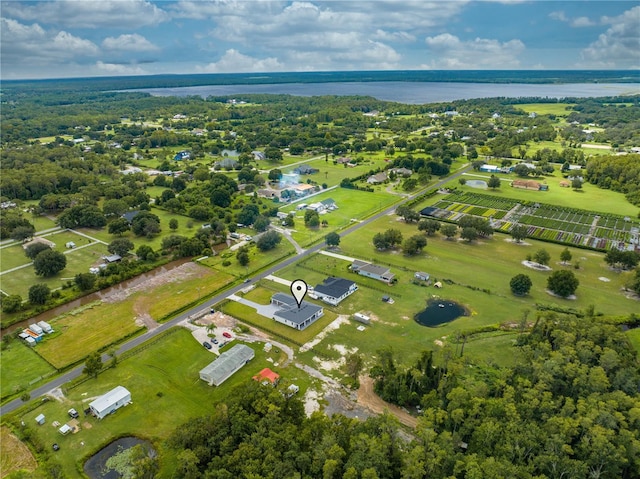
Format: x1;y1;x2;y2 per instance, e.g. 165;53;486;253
438;171;638;217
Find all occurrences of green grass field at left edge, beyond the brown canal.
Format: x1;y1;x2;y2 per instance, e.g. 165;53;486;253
0;246;109;298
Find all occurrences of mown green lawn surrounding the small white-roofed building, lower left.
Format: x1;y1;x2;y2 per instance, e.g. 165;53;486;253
20;328;311;479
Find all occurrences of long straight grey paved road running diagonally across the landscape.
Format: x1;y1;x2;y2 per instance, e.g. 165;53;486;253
0;166;471;416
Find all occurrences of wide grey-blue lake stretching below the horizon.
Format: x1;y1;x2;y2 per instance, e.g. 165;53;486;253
127;81;640;104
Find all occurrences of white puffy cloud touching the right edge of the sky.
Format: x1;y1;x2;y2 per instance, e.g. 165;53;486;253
581;7;640;68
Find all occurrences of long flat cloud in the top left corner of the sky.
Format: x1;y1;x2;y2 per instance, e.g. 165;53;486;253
2;0;170;28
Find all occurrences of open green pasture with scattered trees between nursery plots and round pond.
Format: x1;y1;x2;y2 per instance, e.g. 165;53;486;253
340;216;638;315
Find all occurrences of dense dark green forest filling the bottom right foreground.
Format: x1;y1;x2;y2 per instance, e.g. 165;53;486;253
169;314;640;479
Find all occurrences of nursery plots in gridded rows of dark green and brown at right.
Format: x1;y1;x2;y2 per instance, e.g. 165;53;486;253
429;191;640;250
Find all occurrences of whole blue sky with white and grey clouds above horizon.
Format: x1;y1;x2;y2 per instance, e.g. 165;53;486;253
0;0;640;79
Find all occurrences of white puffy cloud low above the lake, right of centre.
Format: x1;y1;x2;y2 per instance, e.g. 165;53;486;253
425;33;525;69
